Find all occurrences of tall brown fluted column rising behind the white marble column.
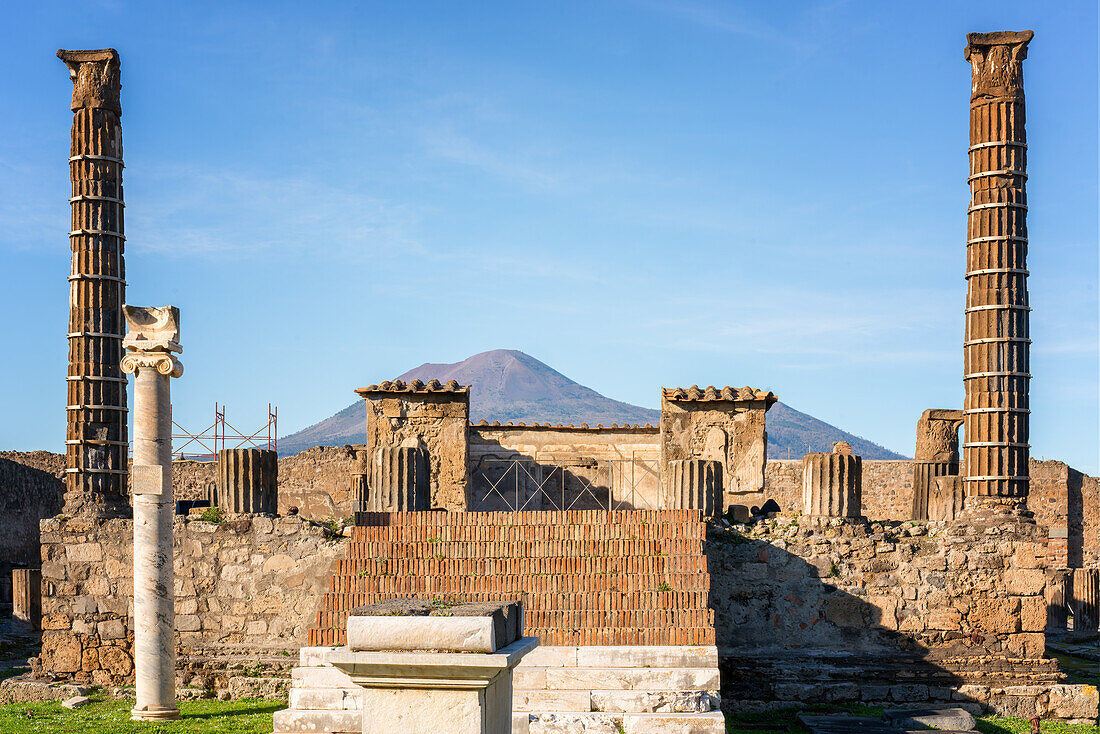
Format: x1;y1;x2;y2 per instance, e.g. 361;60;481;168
57;48;129;517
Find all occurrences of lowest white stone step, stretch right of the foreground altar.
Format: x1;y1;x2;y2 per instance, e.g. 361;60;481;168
512;711;726;734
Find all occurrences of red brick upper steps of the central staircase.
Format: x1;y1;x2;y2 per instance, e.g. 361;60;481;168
309;510;715;646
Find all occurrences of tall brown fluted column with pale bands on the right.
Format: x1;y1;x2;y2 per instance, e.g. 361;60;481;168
963;31;1033;505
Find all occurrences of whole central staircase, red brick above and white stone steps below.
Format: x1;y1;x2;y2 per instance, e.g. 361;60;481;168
275;510;725;734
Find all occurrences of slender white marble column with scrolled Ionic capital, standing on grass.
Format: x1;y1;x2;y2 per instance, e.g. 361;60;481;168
122;306;184;721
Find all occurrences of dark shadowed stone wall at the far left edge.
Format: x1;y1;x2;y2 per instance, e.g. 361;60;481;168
0;451;65;604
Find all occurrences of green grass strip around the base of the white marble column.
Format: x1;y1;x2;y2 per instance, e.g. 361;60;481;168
0;697;286;734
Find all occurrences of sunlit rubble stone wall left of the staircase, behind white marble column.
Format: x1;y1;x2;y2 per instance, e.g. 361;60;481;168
33;516;344;688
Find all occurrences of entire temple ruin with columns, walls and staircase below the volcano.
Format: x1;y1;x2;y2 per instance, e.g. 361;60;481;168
0;31;1100;734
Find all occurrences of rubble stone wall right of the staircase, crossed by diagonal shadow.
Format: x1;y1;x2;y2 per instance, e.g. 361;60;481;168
707;518;1097;719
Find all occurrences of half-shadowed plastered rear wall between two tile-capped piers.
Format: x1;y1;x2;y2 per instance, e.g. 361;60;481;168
469;424;660;510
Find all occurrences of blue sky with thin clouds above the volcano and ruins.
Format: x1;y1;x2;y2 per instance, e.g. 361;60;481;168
0;0;1100;473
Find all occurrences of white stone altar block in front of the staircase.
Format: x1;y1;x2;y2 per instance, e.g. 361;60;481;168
327;599;539;734
